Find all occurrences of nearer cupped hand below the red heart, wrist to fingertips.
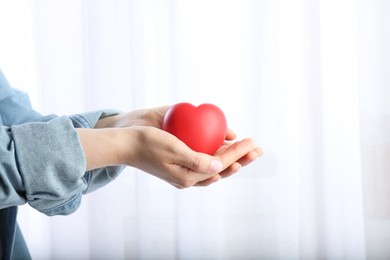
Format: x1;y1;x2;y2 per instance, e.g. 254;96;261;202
124;127;261;188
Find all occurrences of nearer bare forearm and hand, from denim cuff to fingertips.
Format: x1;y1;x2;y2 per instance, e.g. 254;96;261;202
76;126;261;188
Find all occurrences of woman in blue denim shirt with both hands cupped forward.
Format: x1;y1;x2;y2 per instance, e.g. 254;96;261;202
0;70;262;259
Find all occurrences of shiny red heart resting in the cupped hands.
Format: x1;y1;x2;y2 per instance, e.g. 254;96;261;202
162;103;227;155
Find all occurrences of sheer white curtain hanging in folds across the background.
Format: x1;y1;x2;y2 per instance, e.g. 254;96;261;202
0;0;390;259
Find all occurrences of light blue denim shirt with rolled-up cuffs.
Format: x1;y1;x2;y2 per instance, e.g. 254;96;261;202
0;70;123;259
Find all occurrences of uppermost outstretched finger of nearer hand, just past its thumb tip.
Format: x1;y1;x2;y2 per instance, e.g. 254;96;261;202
216;138;256;169
